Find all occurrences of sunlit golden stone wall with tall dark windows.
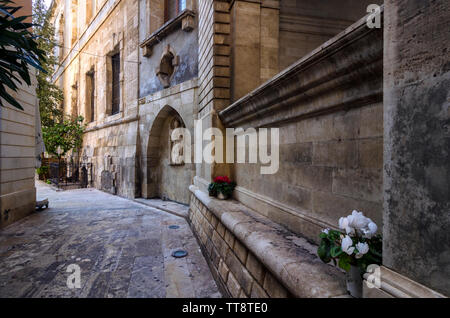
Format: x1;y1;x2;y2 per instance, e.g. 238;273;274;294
53;0;139;198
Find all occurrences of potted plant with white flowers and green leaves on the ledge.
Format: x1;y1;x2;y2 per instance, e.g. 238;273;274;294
317;210;382;298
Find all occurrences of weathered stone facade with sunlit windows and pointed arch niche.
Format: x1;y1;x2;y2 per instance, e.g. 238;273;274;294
52;0;198;204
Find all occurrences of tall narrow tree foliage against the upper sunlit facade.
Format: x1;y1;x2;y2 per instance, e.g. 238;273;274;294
33;0;64;127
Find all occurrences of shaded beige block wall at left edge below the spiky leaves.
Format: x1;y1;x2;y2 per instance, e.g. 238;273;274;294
0;69;39;228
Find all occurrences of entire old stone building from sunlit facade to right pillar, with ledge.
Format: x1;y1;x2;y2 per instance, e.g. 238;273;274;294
51;0;450;297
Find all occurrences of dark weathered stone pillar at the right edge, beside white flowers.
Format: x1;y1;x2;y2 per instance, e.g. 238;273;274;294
381;0;450;297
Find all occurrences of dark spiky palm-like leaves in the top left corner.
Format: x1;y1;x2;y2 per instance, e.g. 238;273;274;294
0;0;45;110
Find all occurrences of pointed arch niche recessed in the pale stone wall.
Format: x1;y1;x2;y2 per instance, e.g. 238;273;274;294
145;105;195;204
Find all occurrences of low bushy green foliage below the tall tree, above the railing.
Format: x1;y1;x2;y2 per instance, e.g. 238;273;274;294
42;116;86;158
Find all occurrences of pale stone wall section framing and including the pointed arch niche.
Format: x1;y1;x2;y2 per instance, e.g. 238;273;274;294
137;79;198;204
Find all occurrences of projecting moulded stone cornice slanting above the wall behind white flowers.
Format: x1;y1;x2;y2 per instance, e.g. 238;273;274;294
219;9;383;127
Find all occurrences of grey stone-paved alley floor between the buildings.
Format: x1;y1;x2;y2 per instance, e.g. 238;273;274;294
0;182;221;297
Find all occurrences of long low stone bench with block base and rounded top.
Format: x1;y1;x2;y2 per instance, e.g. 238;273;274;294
189;185;348;297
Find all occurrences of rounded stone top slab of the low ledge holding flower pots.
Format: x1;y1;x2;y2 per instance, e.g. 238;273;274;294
189;185;347;297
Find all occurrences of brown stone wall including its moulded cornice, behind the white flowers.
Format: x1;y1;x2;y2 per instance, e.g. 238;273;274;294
220;11;383;240
